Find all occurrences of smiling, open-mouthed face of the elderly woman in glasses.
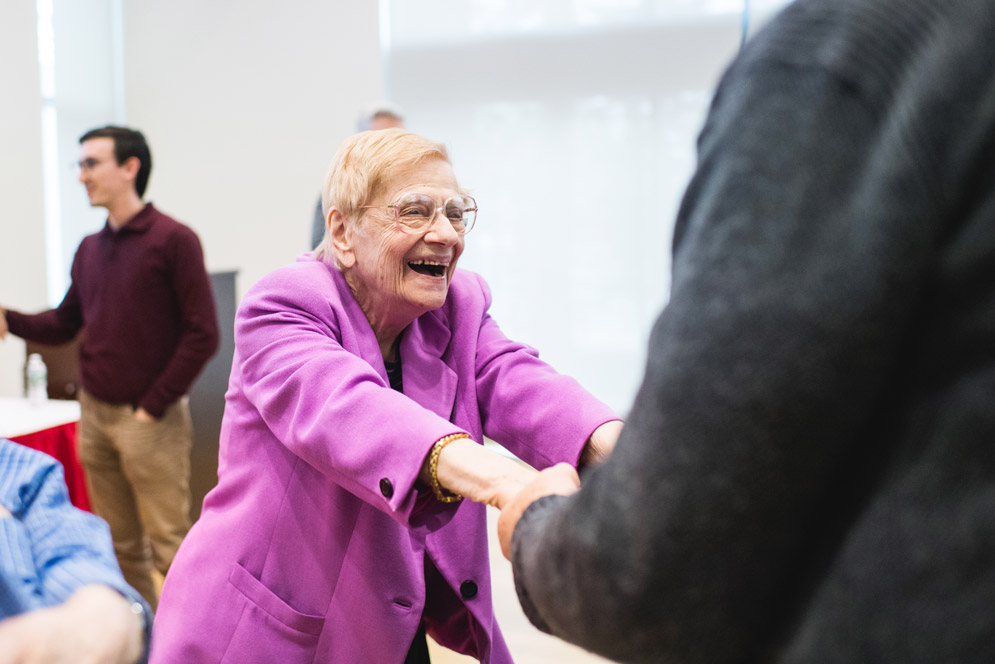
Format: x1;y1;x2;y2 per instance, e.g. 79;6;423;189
336;158;464;337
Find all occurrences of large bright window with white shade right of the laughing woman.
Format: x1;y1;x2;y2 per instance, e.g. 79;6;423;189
390;5;742;415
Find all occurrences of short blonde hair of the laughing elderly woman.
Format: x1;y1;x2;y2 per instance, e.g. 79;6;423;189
315;128;449;262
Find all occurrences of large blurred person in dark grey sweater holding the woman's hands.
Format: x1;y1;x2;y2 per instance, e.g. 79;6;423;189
498;0;995;664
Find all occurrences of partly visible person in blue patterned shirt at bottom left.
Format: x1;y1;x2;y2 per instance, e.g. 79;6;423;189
0;438;151;664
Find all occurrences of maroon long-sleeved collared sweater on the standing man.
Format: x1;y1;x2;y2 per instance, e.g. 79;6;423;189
7;203;218;417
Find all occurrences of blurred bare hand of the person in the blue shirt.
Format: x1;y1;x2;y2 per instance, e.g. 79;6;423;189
0;585;144;664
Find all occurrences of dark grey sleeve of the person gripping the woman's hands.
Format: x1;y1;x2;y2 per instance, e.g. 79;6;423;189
512;35;935;663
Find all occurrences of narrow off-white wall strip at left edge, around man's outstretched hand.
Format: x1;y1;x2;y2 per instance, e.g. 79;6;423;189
0;0;45;397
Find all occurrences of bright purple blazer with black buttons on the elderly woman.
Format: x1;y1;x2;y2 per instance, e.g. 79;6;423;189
151;254;616;664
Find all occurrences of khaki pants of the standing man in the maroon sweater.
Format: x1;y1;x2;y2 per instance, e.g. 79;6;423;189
79;392;193;608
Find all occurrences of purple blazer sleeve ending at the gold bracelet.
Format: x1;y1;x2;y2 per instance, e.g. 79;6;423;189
235;263;461;527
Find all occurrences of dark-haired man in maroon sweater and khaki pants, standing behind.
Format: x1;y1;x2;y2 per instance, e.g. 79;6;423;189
0;127;218;607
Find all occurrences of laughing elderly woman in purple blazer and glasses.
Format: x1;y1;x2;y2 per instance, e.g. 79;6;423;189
152;129;621;664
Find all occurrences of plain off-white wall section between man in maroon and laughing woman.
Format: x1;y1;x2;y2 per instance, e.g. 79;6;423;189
124;0;384;294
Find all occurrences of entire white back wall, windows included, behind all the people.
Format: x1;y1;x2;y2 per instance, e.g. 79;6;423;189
0;0;784;404
